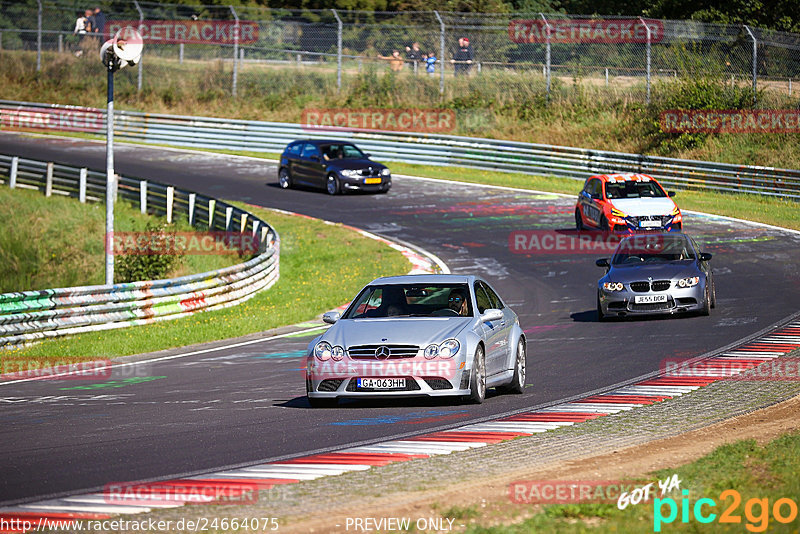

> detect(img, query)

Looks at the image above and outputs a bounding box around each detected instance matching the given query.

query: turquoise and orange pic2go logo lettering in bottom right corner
[653,490,797,532]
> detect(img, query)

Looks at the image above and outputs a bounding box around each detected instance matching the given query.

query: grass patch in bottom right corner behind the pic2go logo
[467,433,800,534]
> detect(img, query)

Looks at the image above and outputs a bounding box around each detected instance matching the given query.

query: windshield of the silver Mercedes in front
[343,284,472,319]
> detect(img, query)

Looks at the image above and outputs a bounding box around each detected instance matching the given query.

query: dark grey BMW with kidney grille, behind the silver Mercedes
[596,232,717,321]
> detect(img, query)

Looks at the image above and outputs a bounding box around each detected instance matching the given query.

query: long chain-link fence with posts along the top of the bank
[0,0,800,106]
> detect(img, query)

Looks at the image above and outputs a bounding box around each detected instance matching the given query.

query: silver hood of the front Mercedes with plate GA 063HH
[322,317,474,348]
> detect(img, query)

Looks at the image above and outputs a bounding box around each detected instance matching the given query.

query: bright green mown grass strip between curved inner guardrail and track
[0,203,410,365]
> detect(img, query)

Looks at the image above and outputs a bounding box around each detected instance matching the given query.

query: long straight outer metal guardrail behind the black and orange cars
[0,100,800,200]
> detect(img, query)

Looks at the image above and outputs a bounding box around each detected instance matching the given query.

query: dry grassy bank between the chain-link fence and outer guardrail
[6,51,800,168]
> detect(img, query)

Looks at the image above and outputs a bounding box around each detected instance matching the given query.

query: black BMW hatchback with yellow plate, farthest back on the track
[278,139,392,195]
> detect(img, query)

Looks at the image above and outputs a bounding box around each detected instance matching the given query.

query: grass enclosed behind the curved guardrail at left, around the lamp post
[0,187,240,293]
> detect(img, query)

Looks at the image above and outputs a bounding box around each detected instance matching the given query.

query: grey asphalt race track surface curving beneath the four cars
[0,134,800,503]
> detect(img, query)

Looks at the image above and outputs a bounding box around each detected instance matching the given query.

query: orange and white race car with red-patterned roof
[575,173,683,232]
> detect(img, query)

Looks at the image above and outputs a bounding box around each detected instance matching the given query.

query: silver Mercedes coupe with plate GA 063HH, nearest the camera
[306,274,525,407]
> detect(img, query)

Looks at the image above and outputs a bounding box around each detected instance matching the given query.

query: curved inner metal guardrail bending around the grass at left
[0,154,280,347]
